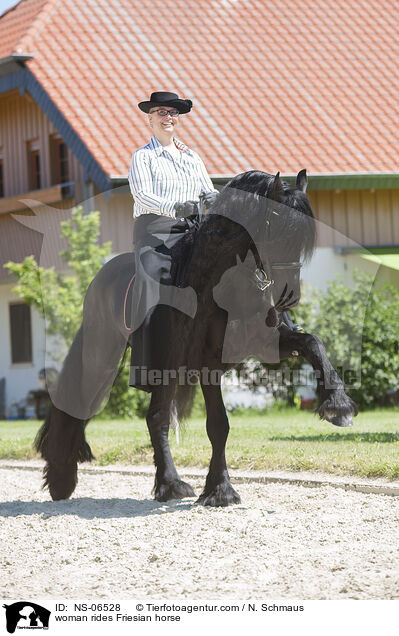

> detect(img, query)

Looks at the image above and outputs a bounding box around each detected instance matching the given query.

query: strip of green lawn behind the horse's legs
[0,408,399,479]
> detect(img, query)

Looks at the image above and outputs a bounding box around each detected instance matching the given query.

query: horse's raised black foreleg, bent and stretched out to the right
[280,325,358,426]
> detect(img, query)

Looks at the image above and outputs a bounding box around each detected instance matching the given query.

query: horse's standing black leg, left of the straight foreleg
[147,390,195,501]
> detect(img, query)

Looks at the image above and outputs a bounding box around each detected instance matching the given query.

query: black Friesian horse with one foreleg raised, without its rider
[35,170,357,506]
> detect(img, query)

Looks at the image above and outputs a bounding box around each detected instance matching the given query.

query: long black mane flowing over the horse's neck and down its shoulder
[171,170,316,413]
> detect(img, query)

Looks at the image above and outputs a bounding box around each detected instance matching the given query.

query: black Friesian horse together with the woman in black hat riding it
[35,93,357,506]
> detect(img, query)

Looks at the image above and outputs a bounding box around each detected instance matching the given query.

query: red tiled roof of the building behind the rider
[0,0,399,175]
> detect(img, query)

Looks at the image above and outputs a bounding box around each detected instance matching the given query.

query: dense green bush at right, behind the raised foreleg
[296,272,399,408]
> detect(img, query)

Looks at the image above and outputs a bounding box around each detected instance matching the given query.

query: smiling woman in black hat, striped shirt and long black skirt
[129,92,218,391]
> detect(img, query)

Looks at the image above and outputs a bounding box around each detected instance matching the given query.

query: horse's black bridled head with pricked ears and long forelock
[211,170,316,311]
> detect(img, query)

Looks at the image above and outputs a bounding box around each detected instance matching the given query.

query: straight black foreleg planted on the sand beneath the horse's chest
[197,384,240,506]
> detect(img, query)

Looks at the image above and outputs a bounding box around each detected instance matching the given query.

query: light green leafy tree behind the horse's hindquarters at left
[5,206,148,417]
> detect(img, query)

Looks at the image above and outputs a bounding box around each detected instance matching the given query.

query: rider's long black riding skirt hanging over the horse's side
[129,214,197,391]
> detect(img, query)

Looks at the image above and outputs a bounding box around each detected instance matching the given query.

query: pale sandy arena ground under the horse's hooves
[0,466,399,600]
